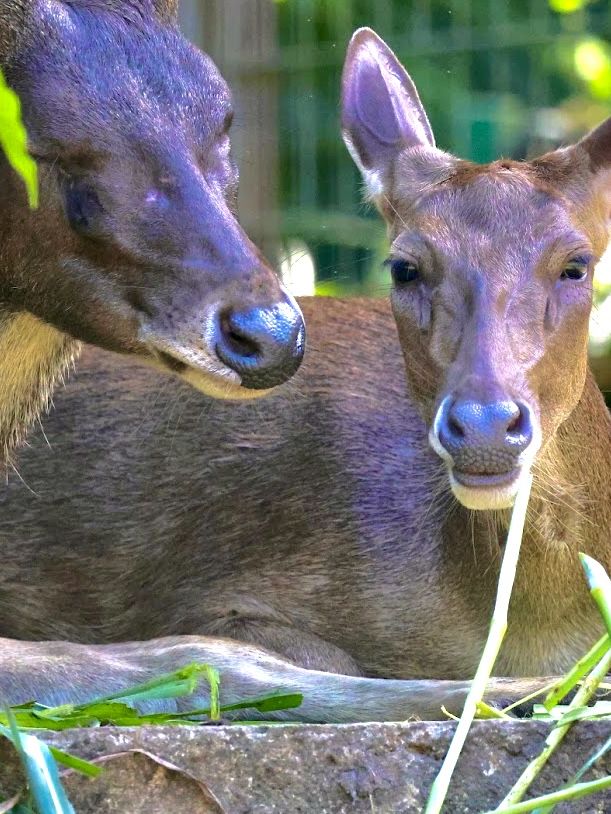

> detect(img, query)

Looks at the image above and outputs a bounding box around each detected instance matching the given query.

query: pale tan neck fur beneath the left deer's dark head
[0,310,79,466]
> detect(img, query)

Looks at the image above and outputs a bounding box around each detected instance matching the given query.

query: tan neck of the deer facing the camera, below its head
[444,375,611,675]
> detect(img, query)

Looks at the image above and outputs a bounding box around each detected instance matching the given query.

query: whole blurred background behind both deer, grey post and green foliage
[181,0,611,392]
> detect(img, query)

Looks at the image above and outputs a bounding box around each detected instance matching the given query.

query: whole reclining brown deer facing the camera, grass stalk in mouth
[0,30,611,721]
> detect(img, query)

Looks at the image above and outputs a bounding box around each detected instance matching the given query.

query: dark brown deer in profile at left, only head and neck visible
[0,0,304,466]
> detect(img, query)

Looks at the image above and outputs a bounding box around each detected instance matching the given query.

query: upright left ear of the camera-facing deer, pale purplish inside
[342,28,435,196]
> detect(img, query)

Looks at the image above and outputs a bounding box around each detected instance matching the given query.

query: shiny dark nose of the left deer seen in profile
[215,300,305,390]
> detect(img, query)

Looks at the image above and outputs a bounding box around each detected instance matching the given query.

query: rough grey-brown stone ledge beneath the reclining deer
[0,721,611,814]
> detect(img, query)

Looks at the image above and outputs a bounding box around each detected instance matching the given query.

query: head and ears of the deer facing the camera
[343,29,611,509]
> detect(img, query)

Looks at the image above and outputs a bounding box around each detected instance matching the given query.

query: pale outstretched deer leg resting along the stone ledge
[0,636,550,723]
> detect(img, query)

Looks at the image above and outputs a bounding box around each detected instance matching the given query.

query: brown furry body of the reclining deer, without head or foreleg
[0,300,611,696]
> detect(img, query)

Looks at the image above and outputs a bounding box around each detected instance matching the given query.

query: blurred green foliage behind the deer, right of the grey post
[278,0,611,296]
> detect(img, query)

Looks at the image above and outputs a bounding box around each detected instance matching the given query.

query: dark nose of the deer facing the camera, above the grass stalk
[437,399,533,475]
